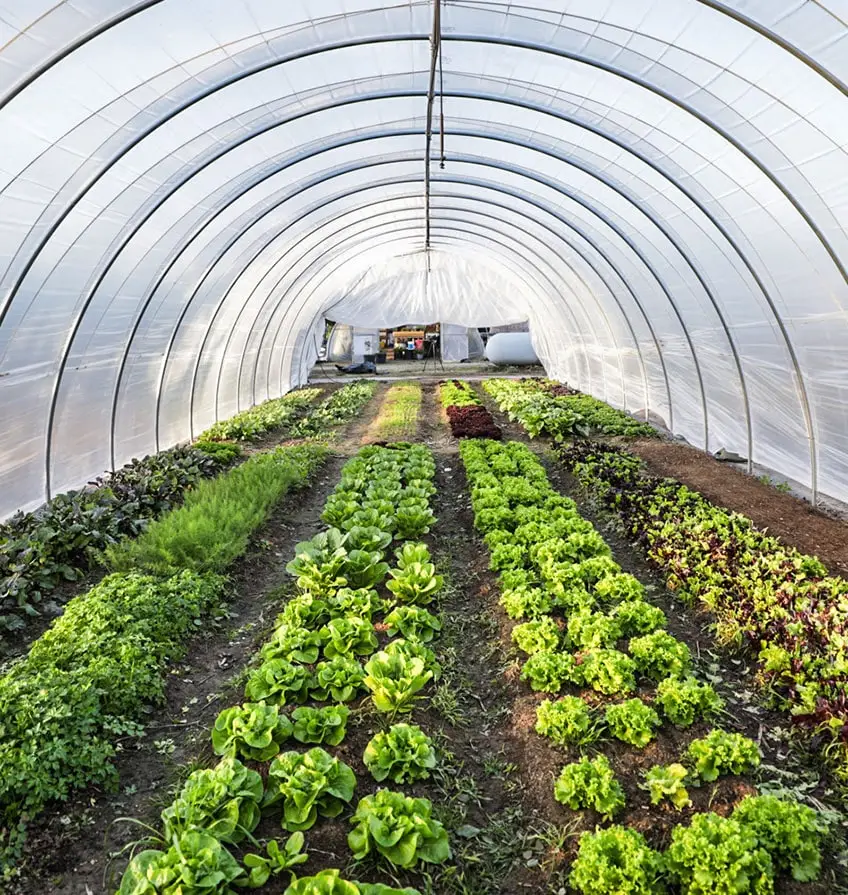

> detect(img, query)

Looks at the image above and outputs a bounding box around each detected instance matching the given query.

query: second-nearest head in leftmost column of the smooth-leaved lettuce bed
[162,758,263,843]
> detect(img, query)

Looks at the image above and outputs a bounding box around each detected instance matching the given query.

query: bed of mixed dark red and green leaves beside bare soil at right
[562,444,848,775]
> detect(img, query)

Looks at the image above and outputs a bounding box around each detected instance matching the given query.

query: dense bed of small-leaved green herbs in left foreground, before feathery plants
[0,572,224,874]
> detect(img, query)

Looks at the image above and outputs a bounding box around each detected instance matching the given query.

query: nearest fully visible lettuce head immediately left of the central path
[347,789,451,868]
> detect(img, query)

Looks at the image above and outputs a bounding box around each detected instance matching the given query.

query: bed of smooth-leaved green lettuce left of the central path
[111,443,451,895]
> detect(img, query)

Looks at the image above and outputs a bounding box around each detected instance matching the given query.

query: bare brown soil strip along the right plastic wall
[626,439,848,576]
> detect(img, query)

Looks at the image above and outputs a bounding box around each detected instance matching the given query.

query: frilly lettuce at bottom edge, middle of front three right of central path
[665,813,774,895]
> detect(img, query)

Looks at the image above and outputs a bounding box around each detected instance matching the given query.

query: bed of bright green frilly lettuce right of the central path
[460,441,824,895]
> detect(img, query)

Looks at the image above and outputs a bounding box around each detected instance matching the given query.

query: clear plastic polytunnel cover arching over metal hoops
[0,0,848,516]
